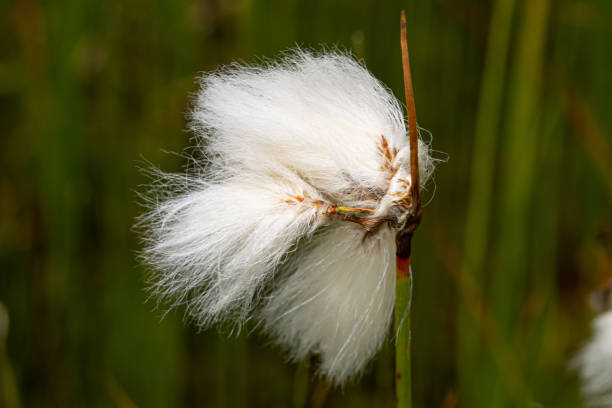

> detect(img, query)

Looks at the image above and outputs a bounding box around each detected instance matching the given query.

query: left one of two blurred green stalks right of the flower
[457,0,515,407]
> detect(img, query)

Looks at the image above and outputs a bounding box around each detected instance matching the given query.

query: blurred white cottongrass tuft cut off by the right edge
[572,310,612,408]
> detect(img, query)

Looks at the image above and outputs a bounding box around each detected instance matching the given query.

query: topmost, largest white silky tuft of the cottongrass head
[191,50,433,201]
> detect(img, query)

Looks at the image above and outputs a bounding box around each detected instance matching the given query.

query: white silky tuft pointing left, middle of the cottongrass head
[143,178,328,327]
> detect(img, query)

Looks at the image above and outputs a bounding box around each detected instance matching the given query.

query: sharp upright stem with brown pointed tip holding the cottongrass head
[395,10,421,408]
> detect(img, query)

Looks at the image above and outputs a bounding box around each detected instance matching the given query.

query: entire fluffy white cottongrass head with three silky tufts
[142,50,433,384]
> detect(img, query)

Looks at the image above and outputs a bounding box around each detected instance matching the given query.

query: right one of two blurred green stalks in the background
[488,0,549,407]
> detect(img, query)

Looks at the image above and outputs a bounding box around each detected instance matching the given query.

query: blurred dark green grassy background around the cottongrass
[0,0,612,408]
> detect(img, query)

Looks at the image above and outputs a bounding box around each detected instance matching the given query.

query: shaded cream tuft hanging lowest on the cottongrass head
[262,224,395,383]
